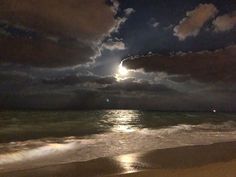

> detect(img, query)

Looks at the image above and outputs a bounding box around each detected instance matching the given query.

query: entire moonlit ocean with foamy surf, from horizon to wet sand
[0,110,236,171]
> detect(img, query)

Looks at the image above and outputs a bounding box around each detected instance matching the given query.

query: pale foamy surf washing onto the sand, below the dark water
[0,121,236,171]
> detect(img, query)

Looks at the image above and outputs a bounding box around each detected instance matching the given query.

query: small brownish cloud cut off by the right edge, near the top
[212,11,236,32]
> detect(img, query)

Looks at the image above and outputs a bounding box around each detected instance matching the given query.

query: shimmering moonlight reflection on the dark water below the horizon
[103,110,140,133]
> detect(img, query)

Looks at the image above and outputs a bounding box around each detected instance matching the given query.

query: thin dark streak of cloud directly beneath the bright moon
[42,75,177,94]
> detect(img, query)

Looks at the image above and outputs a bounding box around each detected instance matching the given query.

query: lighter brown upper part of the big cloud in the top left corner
[0,0,115,40]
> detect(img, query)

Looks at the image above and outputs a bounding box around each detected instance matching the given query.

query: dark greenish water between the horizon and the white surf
[0,110,236,143]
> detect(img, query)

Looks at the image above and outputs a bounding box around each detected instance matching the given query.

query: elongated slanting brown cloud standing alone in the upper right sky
[174,4,218,40]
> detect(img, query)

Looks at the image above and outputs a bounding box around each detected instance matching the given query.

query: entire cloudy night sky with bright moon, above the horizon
[0,0,236,111]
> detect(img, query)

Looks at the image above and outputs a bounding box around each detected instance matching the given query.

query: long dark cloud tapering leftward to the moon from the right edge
[123,45,236,82]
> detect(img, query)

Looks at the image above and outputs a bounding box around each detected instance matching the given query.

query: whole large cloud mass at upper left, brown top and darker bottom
[0,0,120,67]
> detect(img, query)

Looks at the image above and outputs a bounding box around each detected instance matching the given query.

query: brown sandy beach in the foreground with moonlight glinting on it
[0,142,236,177]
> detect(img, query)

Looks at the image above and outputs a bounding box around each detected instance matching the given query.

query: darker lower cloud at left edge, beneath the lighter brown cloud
[0,37,95,67]
